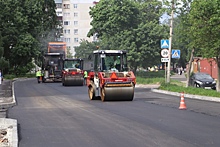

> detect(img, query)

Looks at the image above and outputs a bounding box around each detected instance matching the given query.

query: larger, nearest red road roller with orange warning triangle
[87,50,136,101]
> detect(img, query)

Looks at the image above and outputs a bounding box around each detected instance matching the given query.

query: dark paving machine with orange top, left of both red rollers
[42,42,66,82]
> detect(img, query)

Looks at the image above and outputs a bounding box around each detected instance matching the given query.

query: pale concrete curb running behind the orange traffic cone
[151,89,220,102]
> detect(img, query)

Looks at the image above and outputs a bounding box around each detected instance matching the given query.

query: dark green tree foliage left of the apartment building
[0,0,58,74]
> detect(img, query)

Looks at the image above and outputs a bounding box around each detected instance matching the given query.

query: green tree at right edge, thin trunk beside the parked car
[186,0,220,91]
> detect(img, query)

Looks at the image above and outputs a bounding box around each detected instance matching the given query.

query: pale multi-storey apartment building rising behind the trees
[55,0,98,56]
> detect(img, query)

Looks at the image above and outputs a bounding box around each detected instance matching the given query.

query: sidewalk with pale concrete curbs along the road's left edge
[0,80,18,147]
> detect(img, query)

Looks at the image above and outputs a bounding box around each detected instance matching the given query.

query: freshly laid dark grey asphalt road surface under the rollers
[8,79,220,147]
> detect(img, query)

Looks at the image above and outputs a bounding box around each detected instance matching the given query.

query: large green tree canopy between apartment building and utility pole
[88,0,168,71]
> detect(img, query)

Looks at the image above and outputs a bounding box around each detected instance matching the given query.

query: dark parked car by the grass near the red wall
[190,72,216,89]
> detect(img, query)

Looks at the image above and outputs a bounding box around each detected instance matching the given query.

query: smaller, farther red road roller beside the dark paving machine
[62,58,84,86]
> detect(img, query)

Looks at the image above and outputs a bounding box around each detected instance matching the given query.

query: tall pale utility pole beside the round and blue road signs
[167,0,174,83]
